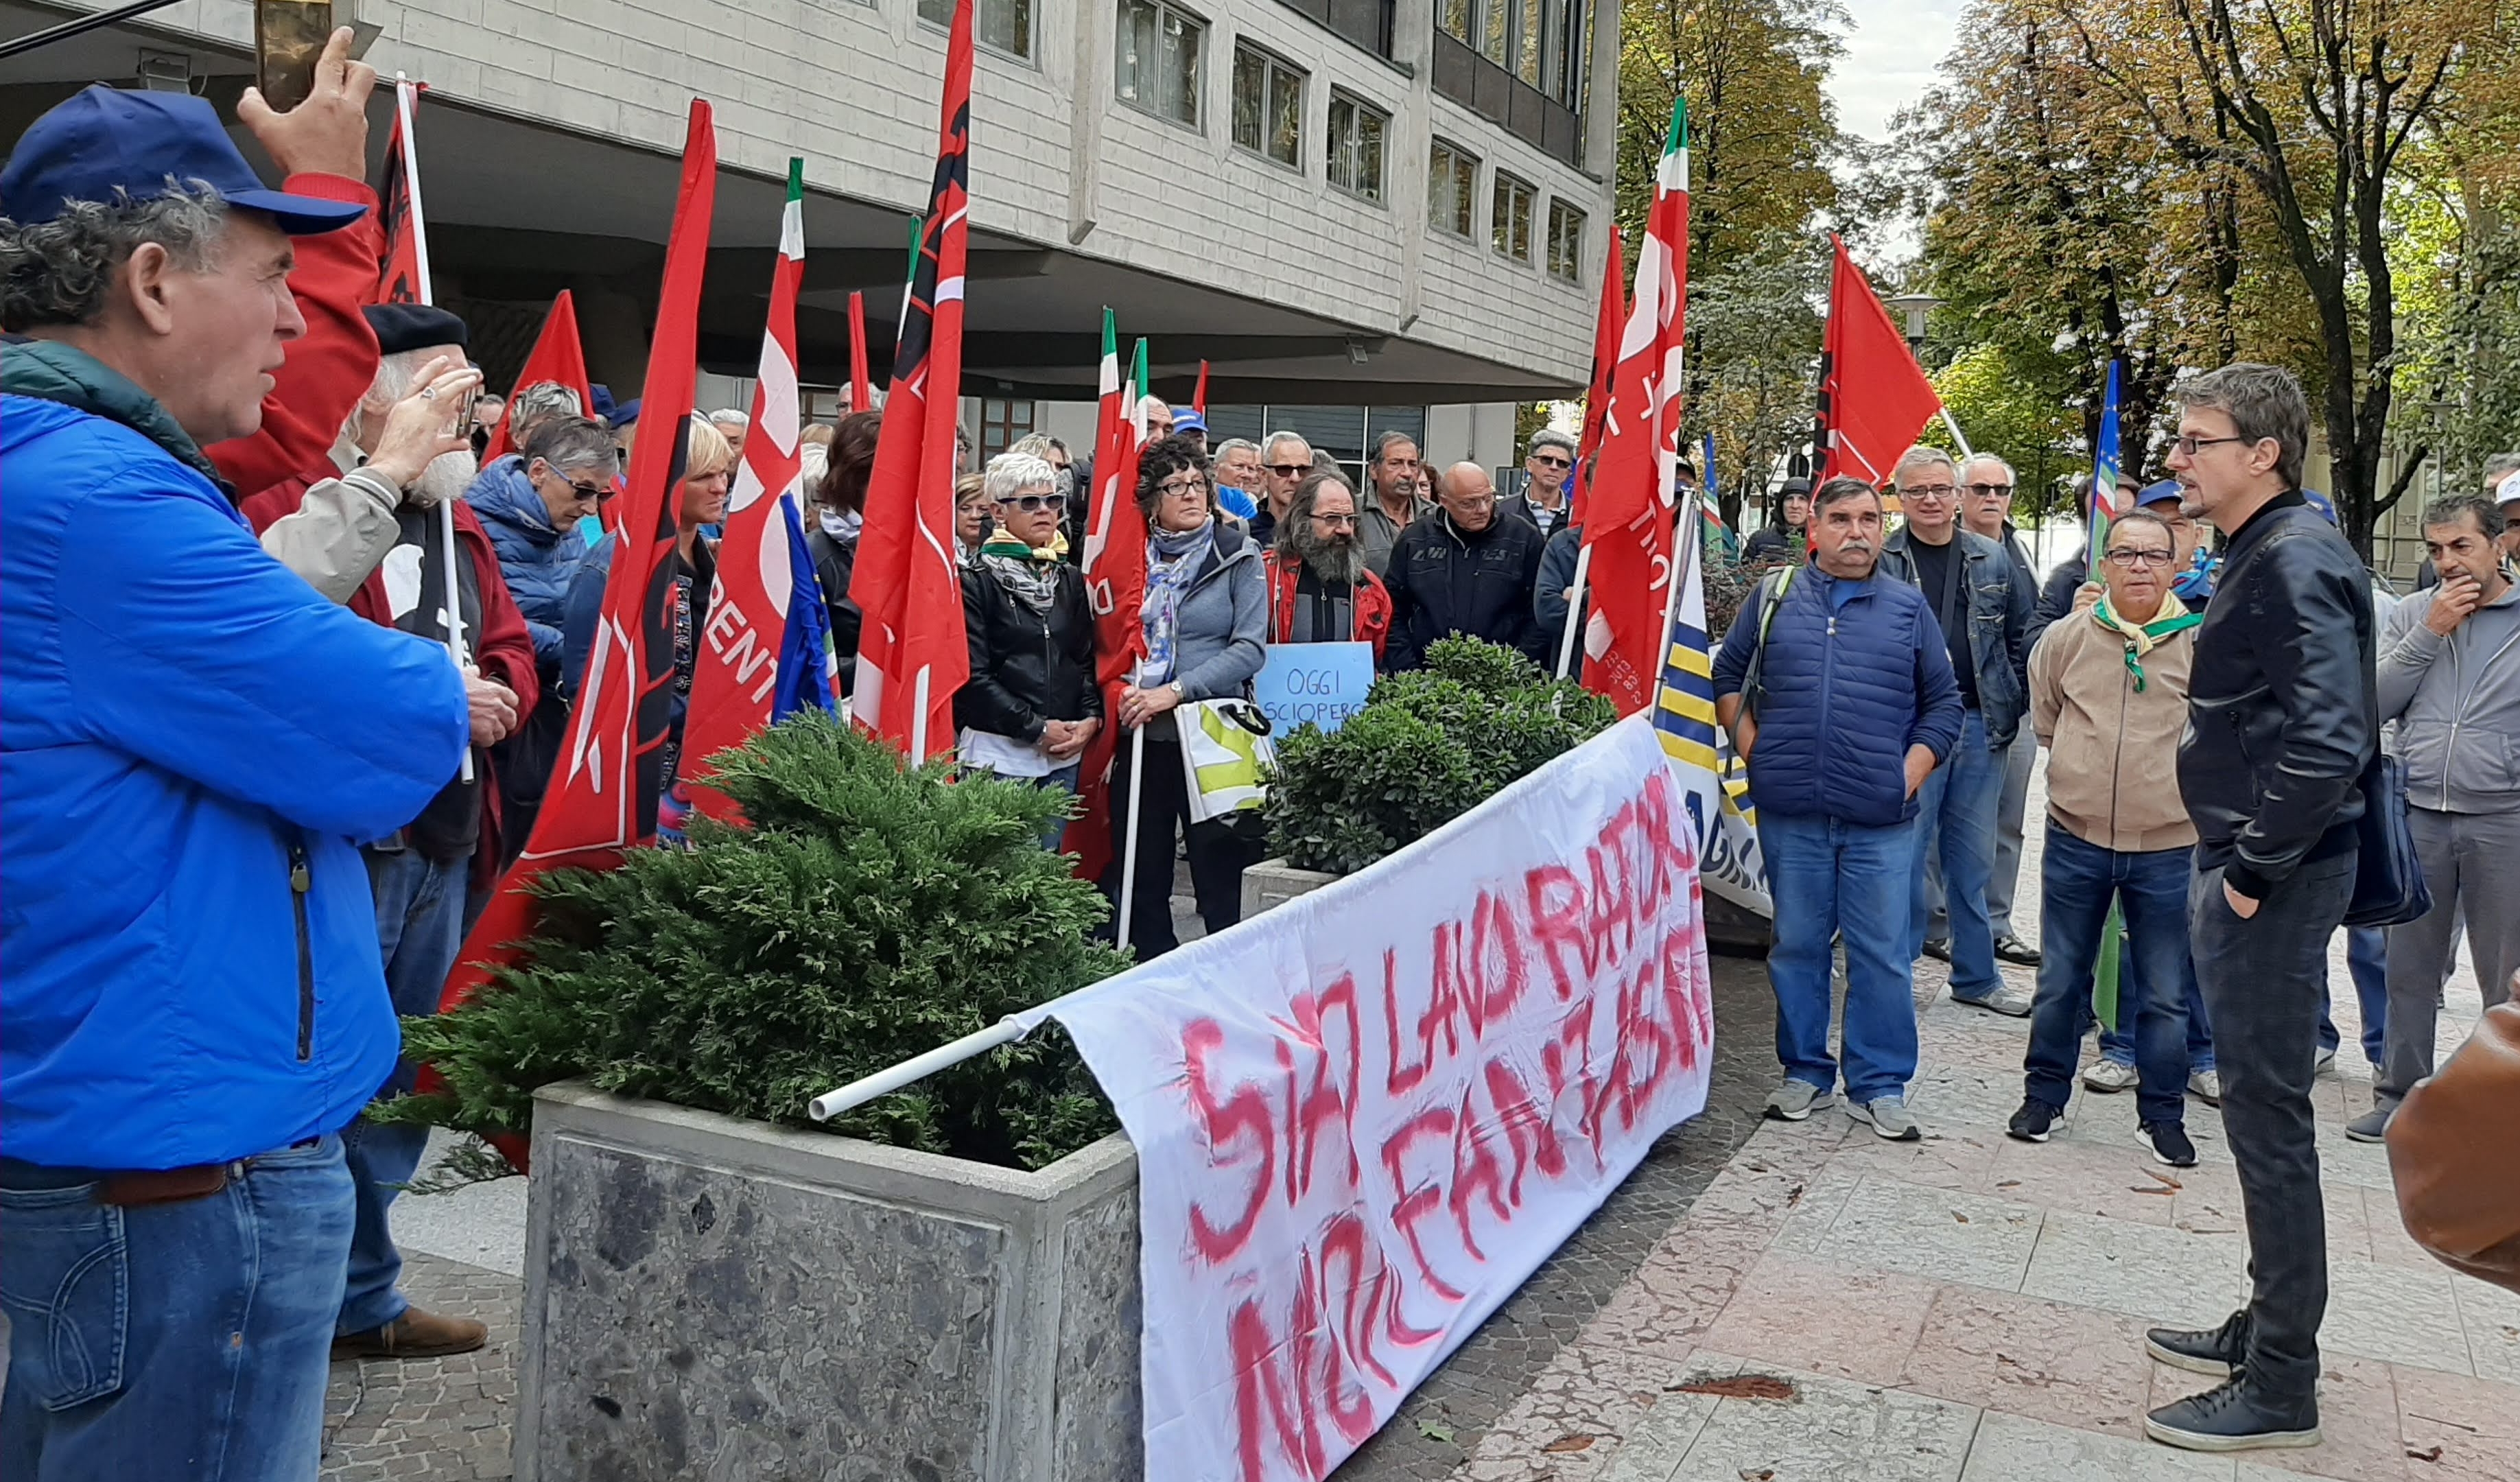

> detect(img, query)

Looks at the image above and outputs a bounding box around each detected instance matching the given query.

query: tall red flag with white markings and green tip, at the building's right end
[1583,101,1688,716]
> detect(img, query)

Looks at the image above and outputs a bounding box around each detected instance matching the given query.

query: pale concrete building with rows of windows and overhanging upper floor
[0,0,1618,464]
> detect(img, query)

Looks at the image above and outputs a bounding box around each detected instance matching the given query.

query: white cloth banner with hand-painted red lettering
[1056,716,1714,1482]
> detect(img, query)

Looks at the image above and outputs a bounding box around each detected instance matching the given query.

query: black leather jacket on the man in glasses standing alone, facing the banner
[2180,491,2379,899]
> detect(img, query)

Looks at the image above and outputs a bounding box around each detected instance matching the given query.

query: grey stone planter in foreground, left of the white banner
[514,1084,1144,1482]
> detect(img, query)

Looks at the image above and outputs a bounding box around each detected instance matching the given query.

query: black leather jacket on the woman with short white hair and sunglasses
[952,560,1101,741]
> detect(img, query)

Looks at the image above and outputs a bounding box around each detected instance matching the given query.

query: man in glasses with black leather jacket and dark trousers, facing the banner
[2145,363,2379,1452]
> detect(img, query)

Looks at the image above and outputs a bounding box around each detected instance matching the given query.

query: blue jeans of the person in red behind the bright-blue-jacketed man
[335,849,471,1333]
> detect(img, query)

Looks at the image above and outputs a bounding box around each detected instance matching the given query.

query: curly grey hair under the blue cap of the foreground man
[0,176,227,333]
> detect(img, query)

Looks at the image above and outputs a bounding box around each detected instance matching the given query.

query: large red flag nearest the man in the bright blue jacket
[441,98,718,1018]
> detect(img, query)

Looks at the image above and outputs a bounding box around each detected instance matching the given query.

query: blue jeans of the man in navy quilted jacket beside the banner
[1759,809,1915,1101]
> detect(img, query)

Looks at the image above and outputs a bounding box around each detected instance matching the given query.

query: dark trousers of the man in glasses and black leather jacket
[2187,854,2354,1401]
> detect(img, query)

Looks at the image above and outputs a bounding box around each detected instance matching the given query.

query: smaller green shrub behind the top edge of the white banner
[1268,637,1618,875]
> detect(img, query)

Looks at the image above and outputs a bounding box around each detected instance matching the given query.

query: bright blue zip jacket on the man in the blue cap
[0,343,469,1169]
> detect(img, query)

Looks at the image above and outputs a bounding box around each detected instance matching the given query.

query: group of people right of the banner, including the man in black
[1714,363,2520,1452]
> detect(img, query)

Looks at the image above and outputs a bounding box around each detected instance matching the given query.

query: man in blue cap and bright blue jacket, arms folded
[0,43,486,1479]
